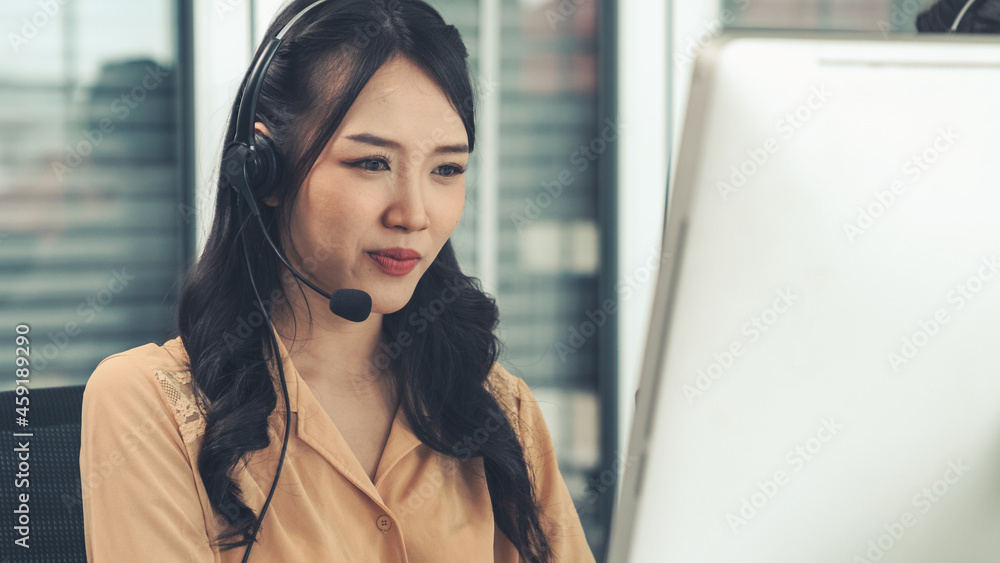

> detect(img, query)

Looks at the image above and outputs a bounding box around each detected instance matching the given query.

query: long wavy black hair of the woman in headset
[178,0,551,562]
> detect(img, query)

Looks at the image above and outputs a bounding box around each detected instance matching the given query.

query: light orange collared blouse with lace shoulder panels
[80,328,594,563]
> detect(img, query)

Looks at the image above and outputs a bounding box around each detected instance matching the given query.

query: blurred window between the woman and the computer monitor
[433,0,618,555]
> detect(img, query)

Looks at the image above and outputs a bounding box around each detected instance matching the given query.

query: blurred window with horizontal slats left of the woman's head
[0,0,187,389]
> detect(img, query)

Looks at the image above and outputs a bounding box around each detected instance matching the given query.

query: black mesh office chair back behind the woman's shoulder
[0,385,87,563]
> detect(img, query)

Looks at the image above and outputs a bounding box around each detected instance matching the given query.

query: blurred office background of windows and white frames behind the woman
[0,0,944,560]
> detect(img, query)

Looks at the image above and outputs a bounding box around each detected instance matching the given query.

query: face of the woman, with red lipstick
[271,57,469,315]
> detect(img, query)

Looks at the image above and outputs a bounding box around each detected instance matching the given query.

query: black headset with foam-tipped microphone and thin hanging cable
[222,0,372,563]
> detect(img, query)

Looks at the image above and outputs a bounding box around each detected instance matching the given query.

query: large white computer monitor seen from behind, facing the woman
[609,34,1000,563]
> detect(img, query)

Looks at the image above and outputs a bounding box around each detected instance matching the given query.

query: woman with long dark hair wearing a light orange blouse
[80,0,594,563]
